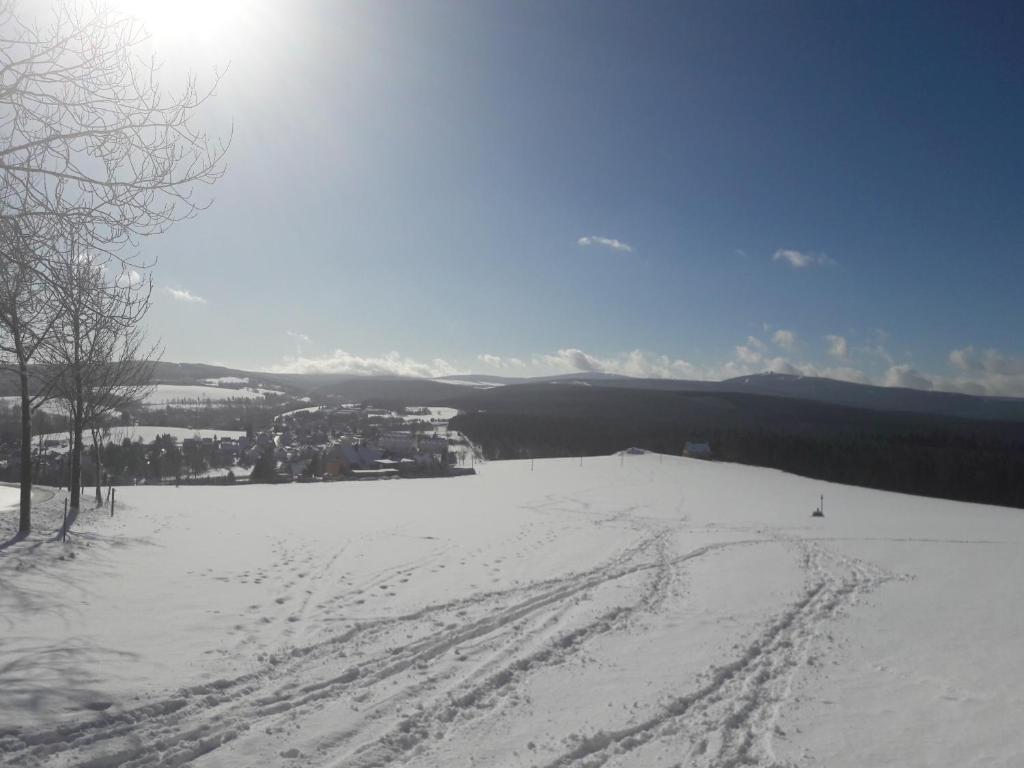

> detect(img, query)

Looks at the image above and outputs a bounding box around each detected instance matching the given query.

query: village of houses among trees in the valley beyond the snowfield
[0,403,476,487]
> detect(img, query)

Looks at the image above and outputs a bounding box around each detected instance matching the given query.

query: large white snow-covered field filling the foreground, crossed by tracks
[0,455,1024,768]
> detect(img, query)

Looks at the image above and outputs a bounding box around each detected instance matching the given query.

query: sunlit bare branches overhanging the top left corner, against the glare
[0,0,228,260]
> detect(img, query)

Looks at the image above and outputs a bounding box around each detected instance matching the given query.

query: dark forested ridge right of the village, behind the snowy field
[451,390,1024,508]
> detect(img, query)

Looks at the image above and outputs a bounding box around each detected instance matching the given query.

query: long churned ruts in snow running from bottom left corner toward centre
[0,530,714,767]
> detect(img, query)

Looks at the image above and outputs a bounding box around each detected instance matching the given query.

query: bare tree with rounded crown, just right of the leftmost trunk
[45,243,159,512]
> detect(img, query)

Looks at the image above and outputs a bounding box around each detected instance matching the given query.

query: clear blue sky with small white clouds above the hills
[125,0,1024,395]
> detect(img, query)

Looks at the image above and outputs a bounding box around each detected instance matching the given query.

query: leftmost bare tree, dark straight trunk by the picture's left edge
[0,220,56,534]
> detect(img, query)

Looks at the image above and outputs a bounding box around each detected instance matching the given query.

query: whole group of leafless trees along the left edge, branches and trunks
[0,0,227,534]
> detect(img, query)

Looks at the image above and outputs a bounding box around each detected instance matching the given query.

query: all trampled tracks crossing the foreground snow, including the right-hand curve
[0,475,894,768]
